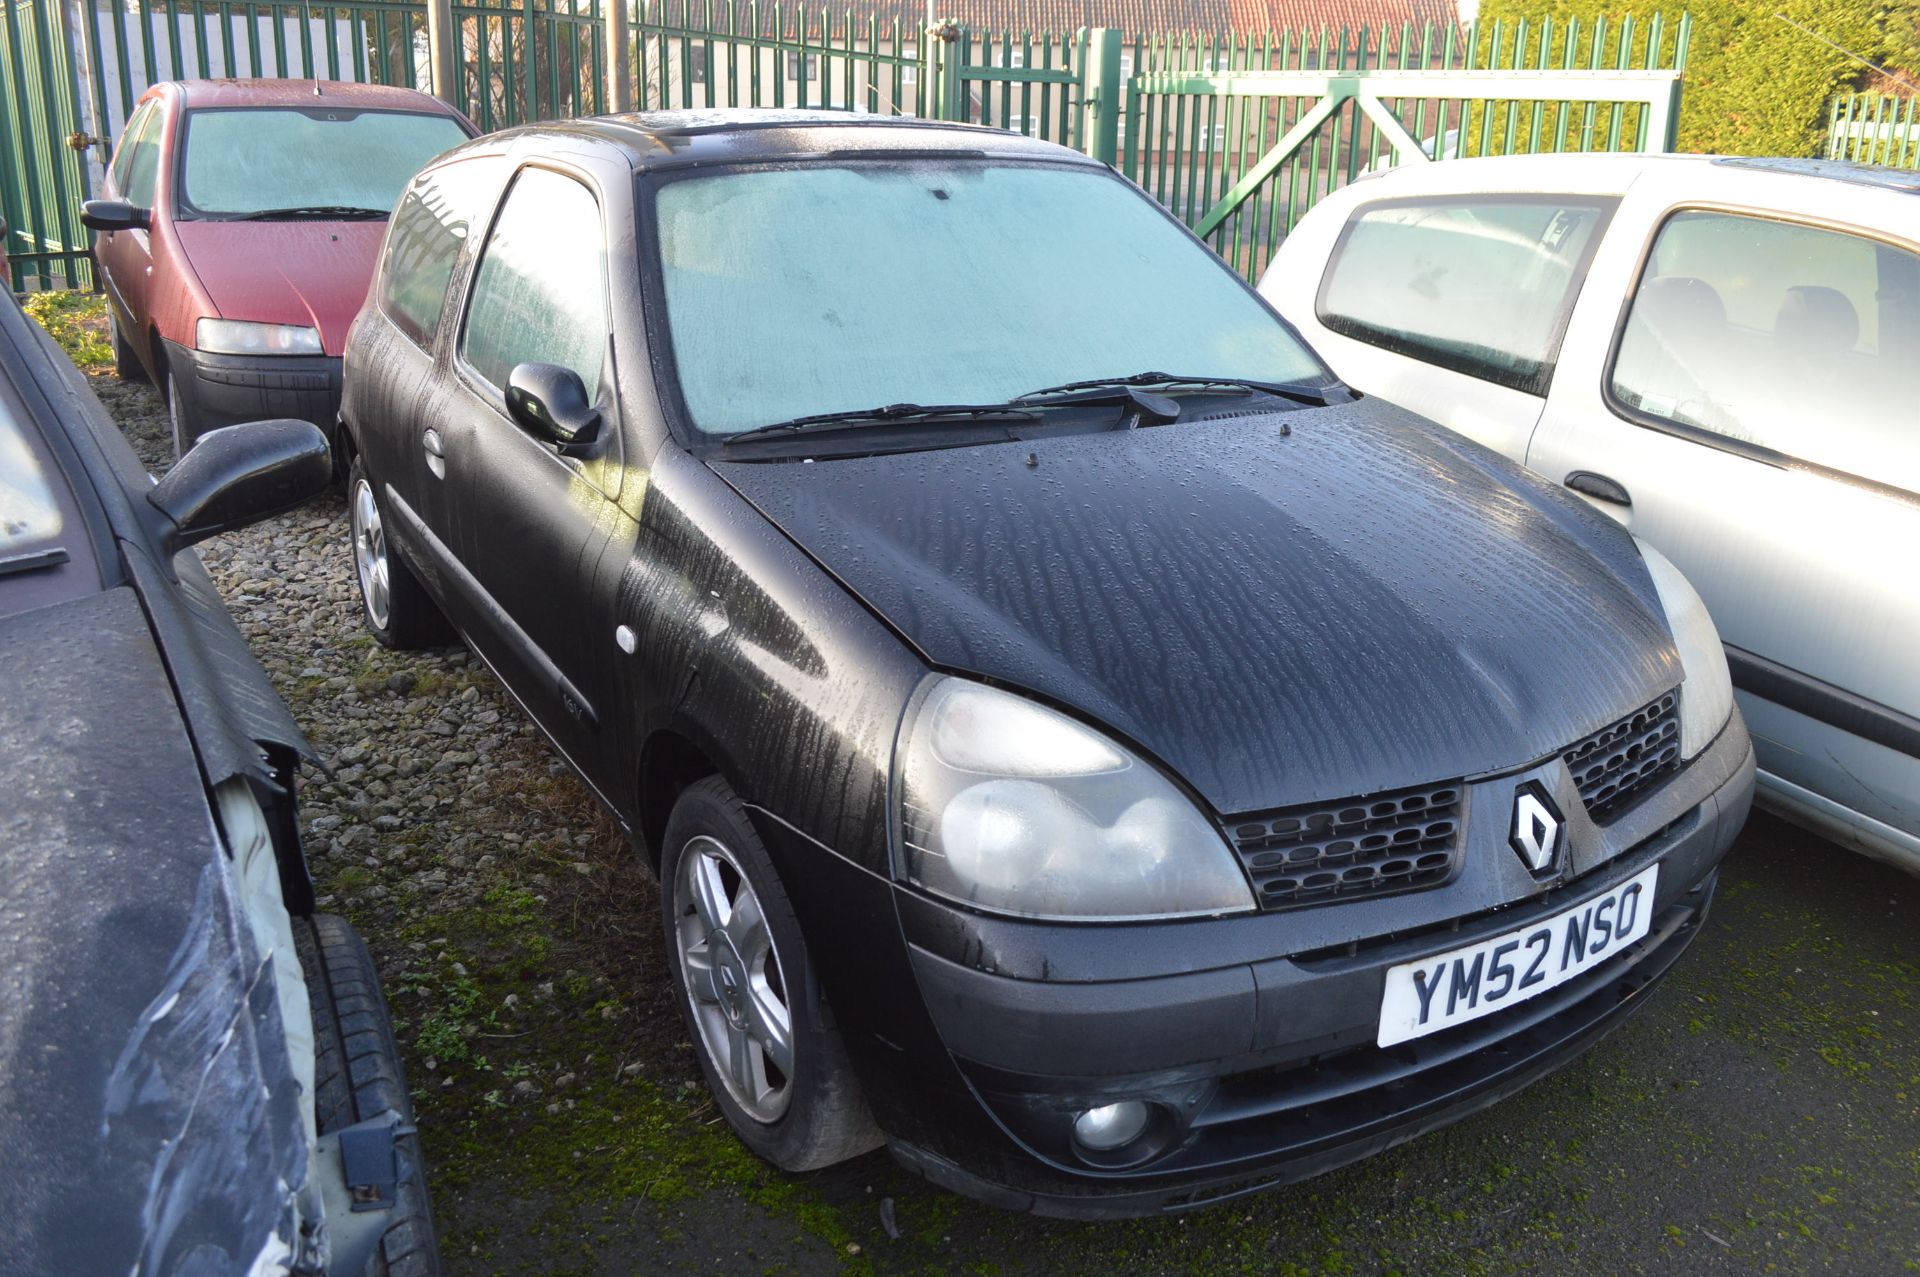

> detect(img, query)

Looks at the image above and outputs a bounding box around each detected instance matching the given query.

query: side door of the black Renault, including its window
[444,163,622,778]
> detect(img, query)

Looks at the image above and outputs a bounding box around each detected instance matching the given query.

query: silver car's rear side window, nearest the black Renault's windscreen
[1317,196,1615,396]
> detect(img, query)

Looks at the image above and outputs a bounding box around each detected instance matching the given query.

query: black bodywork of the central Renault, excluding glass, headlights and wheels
[344,113,1751,1210]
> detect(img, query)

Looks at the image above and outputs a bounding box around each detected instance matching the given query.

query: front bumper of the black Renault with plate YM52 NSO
[893,714,1753,1217]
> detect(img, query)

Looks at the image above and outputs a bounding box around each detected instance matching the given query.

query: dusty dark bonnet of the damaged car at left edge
[0,586,307,1273]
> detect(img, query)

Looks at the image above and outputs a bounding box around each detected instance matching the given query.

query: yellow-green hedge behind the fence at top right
[1480,0,1920,156]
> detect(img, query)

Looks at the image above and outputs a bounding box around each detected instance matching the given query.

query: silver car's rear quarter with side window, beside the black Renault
[1261,181,1617,461]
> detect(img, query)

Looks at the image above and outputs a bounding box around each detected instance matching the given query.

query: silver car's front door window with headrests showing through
[1613,211,1920,492]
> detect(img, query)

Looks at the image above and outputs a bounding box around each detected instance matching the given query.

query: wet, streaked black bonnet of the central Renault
[716,401,1680,812]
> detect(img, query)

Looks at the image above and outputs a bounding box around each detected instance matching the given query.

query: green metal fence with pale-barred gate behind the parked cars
[11,0,1697,291]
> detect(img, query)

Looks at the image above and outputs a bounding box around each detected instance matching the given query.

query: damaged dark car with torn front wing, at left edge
[0,300,440,1277]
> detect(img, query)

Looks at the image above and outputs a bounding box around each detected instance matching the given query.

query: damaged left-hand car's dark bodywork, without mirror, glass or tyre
[0,300,332,1273]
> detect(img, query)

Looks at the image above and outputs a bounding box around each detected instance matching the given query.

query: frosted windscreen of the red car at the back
[180,108,467,217]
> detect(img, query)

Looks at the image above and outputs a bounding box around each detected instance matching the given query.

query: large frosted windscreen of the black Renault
[655,161,1325,434]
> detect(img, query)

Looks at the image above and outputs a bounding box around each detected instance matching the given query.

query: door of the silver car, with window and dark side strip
[1528,165,1920,855]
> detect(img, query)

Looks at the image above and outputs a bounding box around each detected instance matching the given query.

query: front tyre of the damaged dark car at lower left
[294,914,440,1277]
